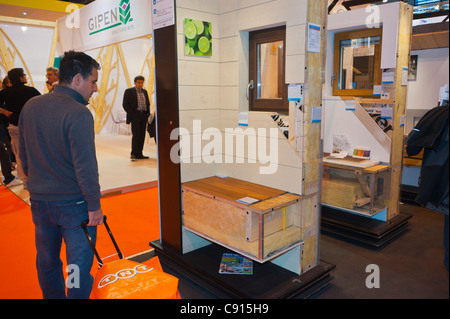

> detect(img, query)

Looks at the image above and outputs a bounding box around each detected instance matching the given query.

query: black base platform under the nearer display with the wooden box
[150,240,336,299]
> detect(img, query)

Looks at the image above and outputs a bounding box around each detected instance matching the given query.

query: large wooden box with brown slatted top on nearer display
[182,176,301,262]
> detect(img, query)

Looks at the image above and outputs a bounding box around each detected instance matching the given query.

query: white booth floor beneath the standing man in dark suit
[7,134,158,204]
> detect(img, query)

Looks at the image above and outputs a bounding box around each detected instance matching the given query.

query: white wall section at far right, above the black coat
[406,48,449,110]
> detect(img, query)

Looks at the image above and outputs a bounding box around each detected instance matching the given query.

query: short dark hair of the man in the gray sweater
[59,50,100,84]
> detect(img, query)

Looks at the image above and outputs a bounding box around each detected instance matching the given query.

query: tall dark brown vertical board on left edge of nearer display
[153,18,183,253]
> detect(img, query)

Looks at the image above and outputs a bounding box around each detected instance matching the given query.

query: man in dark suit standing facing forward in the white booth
[122,75,150,161]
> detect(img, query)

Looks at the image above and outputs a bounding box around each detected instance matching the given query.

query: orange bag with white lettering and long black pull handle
[82,216,181,299]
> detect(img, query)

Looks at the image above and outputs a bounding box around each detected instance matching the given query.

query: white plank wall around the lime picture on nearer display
[177,0,307,193]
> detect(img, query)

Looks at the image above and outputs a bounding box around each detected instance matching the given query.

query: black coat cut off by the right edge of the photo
[406,103,449,271]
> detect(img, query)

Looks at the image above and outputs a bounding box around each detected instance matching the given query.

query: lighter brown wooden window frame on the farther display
[333,28,383,97]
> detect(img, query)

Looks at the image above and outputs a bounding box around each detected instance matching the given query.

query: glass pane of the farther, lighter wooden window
[338,36,380,90]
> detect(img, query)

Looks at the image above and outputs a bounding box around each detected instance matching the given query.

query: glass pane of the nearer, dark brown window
[256,41,284,99]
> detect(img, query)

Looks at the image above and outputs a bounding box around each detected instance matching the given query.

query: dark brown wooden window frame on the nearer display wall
[249,26,289,113]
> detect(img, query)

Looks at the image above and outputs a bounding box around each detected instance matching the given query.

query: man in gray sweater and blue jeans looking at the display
[19,51,103,299]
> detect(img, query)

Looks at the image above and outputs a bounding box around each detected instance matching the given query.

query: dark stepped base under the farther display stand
[321,206,411,247]
